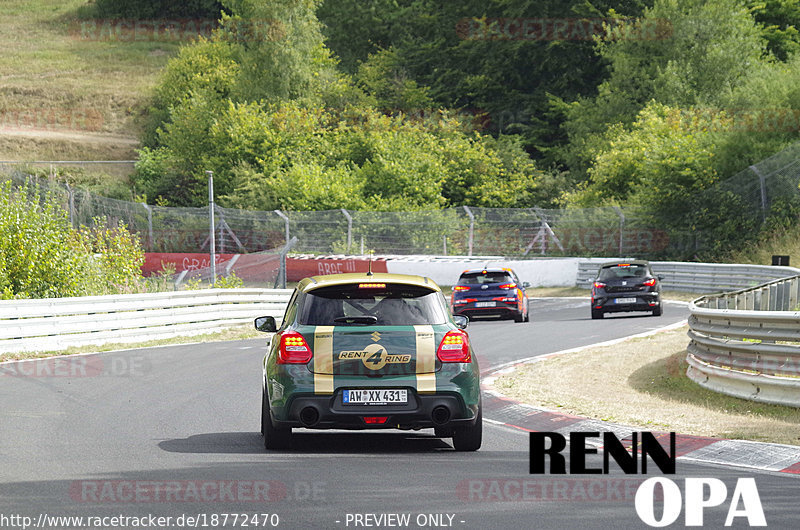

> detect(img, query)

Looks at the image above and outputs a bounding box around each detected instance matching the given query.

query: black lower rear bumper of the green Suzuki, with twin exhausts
[272,389,478,430]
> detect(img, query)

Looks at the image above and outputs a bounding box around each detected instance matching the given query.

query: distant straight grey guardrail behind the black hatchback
[576,260,800,293]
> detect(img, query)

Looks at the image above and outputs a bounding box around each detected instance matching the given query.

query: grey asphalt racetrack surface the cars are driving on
[0,299,800,529]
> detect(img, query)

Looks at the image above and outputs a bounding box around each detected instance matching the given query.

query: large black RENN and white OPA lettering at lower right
[528,431,767,528]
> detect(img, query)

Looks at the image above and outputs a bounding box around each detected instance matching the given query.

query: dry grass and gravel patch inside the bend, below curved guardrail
[495,328,800,445]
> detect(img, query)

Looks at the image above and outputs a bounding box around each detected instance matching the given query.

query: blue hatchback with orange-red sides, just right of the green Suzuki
[450,268,530,322]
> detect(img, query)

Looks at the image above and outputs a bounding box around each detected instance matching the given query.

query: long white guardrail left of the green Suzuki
[0,289,292,355]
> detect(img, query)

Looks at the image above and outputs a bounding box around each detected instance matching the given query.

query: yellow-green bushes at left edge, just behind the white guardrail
[0,181,144,298]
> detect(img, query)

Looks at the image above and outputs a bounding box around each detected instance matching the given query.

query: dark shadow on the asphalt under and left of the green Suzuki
[158,430,453,454]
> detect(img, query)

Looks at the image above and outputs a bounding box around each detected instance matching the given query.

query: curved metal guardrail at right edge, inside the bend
[686,276,800,407]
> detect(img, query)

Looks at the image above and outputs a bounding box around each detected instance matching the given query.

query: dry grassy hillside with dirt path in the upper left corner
[0,0,186,165]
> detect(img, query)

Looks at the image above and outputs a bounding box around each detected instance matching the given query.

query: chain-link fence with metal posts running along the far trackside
[0,139,800,259]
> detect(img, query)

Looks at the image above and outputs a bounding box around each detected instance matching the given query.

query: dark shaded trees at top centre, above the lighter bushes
[319,0,651,165]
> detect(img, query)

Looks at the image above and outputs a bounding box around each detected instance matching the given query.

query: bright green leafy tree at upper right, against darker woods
[561,0,767,179]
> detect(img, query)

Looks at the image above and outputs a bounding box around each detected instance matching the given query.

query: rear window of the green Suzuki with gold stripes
[298,283,448,326]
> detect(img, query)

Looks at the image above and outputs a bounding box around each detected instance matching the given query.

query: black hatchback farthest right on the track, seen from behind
[592,261,661,318]
